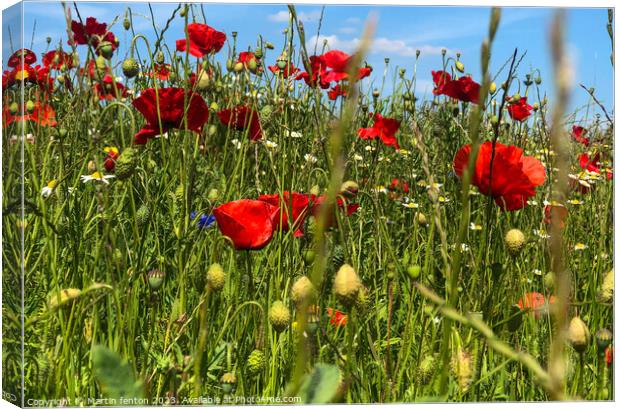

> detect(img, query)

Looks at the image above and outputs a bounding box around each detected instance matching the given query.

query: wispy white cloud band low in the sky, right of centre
[308,34,450,57]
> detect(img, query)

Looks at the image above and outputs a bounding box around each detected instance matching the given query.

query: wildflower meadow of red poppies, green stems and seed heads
[2,3,614,406]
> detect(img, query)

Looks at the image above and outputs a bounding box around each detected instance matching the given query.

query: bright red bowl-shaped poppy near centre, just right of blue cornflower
[213,199,280,250]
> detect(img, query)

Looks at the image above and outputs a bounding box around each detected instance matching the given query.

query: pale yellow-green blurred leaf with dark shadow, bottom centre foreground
[299,364,340,403]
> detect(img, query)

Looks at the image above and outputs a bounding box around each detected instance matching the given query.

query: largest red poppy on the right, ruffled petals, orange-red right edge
[454,142,545,211]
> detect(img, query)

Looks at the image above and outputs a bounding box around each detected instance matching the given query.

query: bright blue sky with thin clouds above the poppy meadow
[3,1,614,120]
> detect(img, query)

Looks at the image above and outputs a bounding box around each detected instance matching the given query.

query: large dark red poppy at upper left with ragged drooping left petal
[133,88,209,145]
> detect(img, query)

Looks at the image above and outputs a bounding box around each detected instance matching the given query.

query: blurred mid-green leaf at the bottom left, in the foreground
[91,345,144,400]
